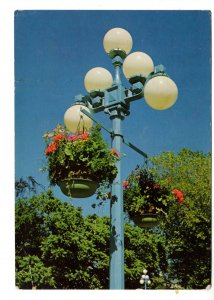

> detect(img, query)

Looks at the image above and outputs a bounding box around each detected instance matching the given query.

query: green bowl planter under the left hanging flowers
[58,178,99,198]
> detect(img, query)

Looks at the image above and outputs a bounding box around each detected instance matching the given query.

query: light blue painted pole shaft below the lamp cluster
[110,116,124,289]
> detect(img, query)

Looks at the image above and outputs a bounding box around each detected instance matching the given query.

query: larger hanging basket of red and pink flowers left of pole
[43,125,120,198]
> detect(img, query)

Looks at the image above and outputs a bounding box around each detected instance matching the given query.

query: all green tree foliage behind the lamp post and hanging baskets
[16,149,211,289]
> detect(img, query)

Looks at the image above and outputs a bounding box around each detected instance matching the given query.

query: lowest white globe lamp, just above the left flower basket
[64,104,93,132]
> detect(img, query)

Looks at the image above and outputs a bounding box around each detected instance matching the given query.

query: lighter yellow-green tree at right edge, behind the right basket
[152,149,211,289]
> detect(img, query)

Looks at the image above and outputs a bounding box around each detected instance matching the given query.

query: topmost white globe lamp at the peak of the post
[103,28,132,54]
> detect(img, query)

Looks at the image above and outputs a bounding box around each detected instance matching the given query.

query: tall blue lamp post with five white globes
[64,28,178,289]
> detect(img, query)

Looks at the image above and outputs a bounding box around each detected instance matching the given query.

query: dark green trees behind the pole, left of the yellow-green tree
[16,191,167,289]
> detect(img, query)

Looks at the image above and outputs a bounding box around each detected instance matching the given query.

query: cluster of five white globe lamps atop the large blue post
[64,28,178,132]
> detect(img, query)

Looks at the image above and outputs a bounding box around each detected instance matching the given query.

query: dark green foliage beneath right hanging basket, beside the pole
[125,224,167,289]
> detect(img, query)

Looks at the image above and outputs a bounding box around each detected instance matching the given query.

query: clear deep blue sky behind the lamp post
[15,10,211,215]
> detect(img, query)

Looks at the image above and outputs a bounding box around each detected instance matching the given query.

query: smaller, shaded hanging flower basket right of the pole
[123,166,169,228]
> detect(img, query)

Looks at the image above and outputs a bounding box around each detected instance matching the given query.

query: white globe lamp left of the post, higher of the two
[84,67,113,93]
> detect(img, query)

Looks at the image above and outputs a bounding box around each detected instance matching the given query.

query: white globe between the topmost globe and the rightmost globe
[123,52,154,79]
